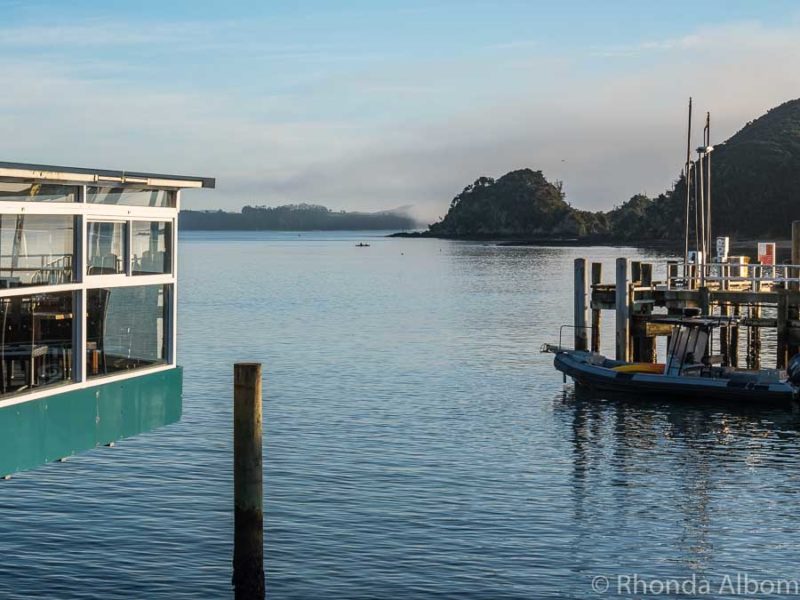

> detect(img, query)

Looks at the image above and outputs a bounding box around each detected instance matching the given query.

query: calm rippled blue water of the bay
[0,233,800,599]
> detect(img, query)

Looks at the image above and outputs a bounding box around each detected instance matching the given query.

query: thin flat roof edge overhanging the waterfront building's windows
[0,161,216,189]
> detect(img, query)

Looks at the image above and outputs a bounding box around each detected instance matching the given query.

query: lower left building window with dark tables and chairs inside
[0,292,73,395]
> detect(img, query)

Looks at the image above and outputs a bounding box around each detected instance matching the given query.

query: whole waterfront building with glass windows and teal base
[0,162,214,475]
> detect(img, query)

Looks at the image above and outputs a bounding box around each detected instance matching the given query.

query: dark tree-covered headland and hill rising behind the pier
[397,99,800,244]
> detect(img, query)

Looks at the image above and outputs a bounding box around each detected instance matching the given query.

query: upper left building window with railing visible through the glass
[0,215,75,288]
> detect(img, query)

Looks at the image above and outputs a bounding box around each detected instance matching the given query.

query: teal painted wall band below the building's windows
[0,367,183,476]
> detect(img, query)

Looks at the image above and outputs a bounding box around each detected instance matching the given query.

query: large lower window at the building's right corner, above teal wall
[86,285,169,378]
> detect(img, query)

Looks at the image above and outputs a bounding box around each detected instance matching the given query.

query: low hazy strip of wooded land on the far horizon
[179,204,419,231]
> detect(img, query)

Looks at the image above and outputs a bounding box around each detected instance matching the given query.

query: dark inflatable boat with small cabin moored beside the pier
[542,317,800,403]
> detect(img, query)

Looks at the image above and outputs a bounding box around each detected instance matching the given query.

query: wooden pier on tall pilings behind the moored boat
[573,221,800,369]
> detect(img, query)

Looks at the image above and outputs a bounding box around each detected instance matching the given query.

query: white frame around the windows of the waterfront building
[0,185,180,408]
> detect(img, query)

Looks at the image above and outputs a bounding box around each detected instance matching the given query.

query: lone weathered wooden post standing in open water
[233,363,265,600]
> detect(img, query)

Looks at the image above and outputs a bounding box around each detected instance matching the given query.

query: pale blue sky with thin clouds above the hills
[0,0,800,222]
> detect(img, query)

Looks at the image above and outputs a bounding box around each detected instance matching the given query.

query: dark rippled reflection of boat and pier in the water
[553,386,800,574]
